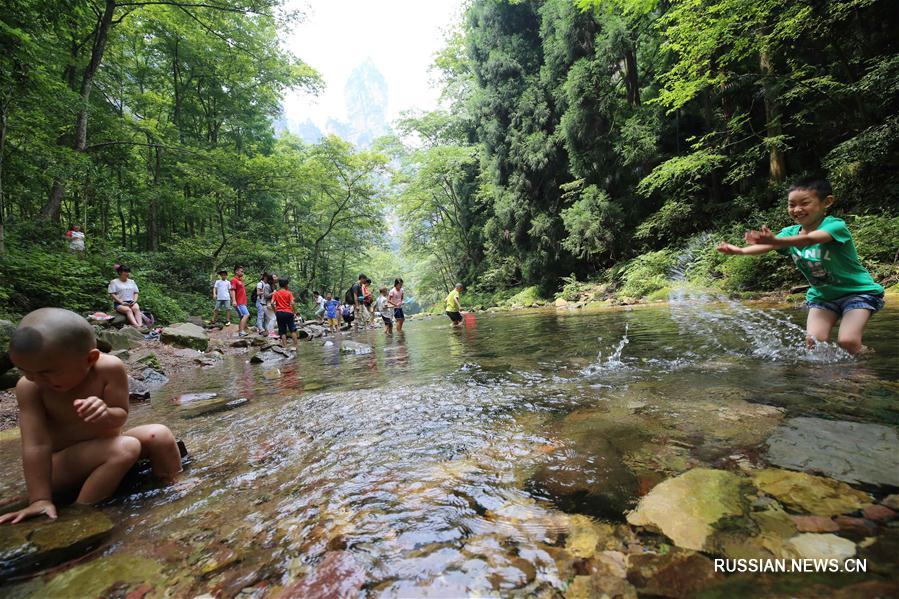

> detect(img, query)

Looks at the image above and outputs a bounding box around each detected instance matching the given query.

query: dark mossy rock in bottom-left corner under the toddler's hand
[0,505,113,577]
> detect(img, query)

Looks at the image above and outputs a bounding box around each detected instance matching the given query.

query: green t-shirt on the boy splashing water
[777,216,883,302]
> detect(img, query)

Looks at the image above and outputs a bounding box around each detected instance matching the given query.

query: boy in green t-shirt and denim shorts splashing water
[718,179,883,354]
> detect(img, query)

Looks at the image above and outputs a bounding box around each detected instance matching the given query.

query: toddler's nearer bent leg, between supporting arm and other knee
[52,435,140,504]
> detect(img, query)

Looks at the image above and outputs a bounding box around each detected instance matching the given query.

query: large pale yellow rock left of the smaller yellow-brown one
[627,468,748,550]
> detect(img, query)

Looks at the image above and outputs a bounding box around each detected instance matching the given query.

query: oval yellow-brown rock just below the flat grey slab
[752,468,871,516]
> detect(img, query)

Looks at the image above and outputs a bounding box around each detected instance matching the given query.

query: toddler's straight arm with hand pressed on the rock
[0,378,56,524]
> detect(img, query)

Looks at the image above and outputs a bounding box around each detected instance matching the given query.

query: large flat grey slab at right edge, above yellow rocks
[766,417,899,488]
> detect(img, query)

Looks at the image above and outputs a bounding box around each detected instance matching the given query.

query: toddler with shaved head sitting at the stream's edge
[0,308,181,523]
